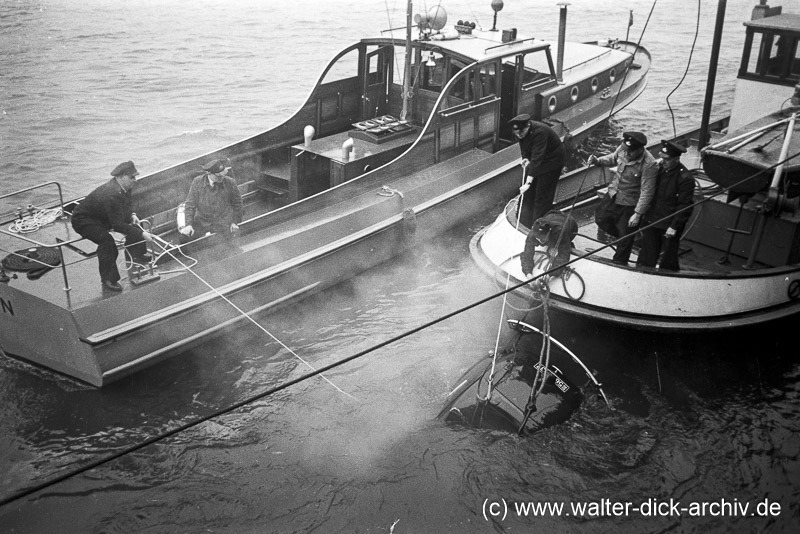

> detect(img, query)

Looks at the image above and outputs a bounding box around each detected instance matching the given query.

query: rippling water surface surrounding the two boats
[0,0,800,533]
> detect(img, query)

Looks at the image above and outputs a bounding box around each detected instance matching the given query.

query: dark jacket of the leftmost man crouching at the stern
[72,178,142,241]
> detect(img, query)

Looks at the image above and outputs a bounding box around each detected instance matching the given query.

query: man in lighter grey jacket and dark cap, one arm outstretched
[589,132,658,265]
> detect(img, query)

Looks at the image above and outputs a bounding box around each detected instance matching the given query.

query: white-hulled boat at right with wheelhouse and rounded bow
[471,2,800,332]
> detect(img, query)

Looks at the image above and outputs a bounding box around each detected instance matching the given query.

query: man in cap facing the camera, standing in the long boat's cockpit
[178,159,243,243]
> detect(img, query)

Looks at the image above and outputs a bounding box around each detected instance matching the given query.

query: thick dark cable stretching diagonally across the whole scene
[0,152,800,506]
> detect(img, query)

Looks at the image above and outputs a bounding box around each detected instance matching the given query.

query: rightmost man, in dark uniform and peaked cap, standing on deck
[636,141,694,271]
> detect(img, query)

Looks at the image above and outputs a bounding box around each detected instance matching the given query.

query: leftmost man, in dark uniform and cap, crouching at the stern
[72,161,153,291]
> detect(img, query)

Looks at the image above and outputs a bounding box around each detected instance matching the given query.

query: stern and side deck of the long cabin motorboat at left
[0,149,500,309]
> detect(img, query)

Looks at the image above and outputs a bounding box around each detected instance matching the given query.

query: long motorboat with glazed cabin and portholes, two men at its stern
[0,3,650,386]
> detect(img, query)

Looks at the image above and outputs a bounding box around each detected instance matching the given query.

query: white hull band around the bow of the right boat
[471,207,800,331]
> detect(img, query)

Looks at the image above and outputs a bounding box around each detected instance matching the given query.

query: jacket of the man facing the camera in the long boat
[185,174,244,229]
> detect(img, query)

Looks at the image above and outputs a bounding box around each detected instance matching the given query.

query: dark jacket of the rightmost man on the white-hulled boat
[643,163,694,232]
